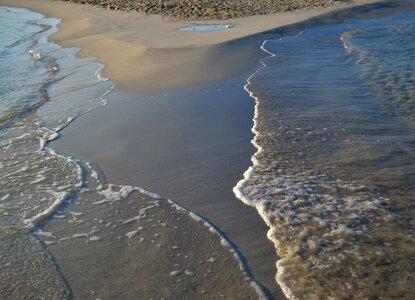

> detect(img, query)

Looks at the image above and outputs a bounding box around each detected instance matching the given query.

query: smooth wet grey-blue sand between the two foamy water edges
[50,72,288,297]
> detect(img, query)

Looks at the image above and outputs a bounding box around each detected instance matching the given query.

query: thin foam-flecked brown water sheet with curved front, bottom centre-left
[39,186,258,299]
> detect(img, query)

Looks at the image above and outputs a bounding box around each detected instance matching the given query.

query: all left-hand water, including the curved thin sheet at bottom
[0,7,263,299]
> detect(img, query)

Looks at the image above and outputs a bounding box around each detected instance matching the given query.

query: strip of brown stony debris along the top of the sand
[57,0,353,19]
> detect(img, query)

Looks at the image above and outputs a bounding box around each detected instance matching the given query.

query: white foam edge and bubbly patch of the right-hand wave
[233,29,402,299]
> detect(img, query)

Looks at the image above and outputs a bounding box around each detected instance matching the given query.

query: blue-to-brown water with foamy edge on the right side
[234,11,415,299]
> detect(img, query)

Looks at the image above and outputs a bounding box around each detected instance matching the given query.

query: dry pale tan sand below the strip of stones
[0,0,386,91]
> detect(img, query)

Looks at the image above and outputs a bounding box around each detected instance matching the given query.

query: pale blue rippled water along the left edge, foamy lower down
[0,7,114,299]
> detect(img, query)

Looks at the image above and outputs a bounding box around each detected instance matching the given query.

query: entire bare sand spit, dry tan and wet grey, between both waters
[0,0,411,298]
